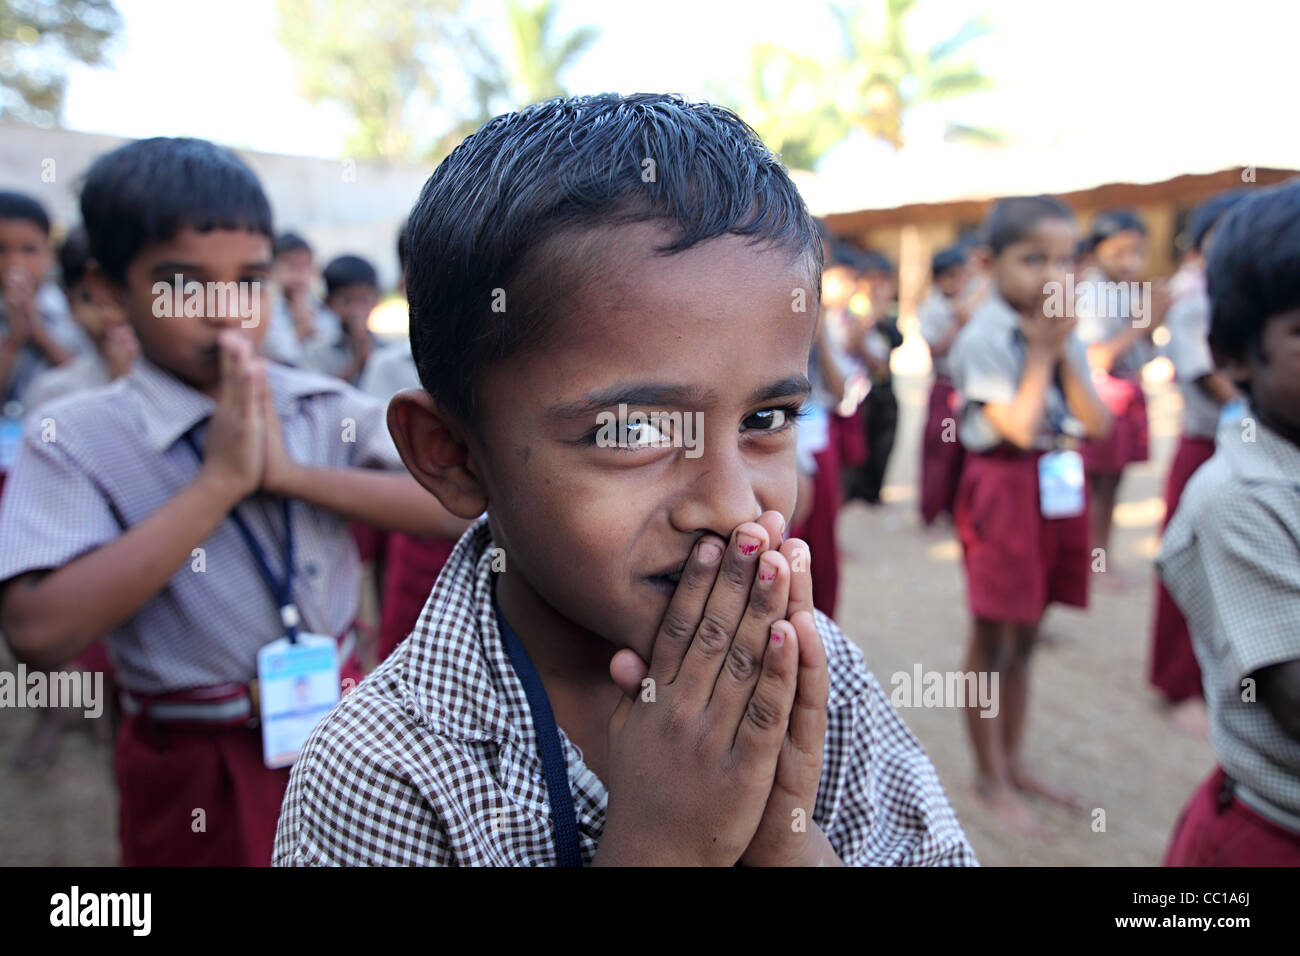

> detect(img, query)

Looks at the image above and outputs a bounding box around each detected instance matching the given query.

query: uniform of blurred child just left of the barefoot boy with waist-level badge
[920,289,966,524]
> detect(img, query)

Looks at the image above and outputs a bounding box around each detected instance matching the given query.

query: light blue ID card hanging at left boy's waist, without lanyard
[257,632,339,770]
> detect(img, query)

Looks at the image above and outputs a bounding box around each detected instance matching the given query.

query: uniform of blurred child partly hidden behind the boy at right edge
[1148,286,1219,702]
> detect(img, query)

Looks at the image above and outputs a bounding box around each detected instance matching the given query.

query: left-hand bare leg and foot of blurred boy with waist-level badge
[963,618,1053,838]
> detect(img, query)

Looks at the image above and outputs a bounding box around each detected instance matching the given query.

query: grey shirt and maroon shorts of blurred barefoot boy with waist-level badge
[950,294,1091,624]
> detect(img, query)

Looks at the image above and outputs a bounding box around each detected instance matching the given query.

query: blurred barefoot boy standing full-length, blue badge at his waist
[950,196,1109,836]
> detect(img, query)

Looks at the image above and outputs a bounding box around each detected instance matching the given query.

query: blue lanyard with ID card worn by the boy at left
[183,432,341,770]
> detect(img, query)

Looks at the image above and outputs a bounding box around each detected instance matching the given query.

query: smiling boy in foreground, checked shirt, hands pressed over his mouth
[276,95,974,865]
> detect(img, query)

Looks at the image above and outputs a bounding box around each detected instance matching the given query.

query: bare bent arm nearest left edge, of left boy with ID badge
[0,475,245,670]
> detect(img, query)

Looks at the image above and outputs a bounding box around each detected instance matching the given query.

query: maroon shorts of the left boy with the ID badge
[116,654,364,866]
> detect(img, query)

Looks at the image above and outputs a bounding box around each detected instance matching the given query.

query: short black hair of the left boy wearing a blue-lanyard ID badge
[81,137,276,284]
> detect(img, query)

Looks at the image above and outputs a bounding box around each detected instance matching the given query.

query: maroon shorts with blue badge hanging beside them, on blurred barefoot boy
[953,451,1091,624]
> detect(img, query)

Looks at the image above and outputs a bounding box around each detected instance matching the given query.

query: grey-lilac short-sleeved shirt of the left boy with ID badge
[0,358,402,693]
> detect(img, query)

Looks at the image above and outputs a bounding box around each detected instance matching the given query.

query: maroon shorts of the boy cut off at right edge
[1164,767,1300,866]
